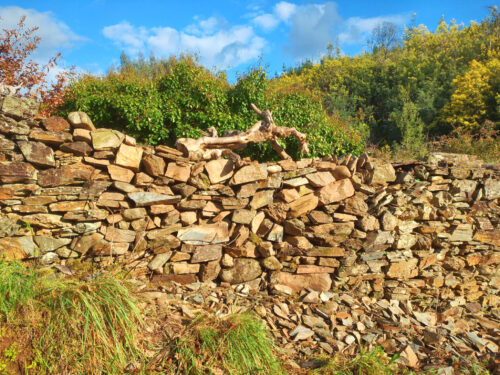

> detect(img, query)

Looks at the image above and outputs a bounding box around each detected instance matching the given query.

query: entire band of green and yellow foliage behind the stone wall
[60,8,500,160]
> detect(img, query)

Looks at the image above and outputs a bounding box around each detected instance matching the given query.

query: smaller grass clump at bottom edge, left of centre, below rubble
[161,313,285,375]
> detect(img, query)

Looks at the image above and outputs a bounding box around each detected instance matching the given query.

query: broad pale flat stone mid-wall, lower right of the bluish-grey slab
[177,222,229,245]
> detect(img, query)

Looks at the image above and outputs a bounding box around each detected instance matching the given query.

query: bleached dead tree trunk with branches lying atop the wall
[175,103,309,160]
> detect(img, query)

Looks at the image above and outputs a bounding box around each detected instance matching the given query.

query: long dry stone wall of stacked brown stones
[0,96,500,304]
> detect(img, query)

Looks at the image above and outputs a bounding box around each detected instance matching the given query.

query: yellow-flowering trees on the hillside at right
[274,8,500,148]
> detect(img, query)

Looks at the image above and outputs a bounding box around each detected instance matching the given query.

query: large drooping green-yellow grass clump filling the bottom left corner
[0,261,142,374]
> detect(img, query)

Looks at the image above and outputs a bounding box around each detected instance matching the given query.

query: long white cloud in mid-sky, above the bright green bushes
[103,17,266,69]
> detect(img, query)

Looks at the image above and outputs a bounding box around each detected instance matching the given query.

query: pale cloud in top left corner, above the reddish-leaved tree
[0,6,85,63]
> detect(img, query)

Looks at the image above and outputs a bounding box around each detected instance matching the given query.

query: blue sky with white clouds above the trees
[0,0,496,79]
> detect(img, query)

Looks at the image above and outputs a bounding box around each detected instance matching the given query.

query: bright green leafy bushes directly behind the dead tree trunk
[61,56,364,159]
